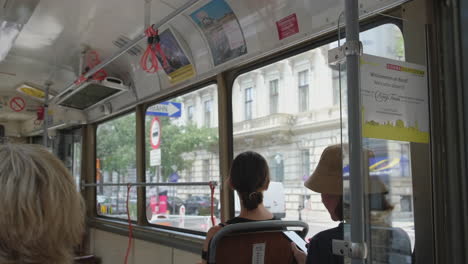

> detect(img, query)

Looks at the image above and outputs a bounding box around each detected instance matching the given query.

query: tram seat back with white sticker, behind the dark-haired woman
[208,220,309,264]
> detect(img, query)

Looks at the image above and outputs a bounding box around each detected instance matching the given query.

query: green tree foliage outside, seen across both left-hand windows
[96,113,218,181]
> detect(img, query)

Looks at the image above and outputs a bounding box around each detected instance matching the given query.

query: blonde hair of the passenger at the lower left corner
[0,144,84,264]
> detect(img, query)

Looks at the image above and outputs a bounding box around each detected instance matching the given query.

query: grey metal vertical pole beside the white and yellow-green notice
[345,0,366,264]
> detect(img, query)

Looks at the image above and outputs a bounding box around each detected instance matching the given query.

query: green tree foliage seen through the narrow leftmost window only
[96,113,136,177]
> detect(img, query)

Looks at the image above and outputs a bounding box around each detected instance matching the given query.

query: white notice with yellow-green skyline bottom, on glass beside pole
[361,55,429,143]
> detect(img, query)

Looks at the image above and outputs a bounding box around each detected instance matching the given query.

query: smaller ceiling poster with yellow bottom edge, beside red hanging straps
[158,29,195,84]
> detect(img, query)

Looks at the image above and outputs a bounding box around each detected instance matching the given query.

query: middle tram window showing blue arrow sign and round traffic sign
[145,84,220,232]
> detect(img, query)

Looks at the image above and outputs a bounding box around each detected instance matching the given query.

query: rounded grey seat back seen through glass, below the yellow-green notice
[371,226,412,264]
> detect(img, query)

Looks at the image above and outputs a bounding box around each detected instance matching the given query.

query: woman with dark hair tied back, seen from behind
[202,151,275,263]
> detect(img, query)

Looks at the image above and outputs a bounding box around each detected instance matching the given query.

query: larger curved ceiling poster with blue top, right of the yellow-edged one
[190,0,247,66]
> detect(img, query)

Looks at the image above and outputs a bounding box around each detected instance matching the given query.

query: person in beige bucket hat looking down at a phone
[291,144,408,264]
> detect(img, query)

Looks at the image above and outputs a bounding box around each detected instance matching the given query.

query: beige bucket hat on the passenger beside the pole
[304,144,388,195]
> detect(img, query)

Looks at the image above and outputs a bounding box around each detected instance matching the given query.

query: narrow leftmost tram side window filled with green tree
[96,113,137,220]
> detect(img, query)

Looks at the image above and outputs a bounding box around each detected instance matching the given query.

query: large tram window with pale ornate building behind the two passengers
[232,24,404,240]
